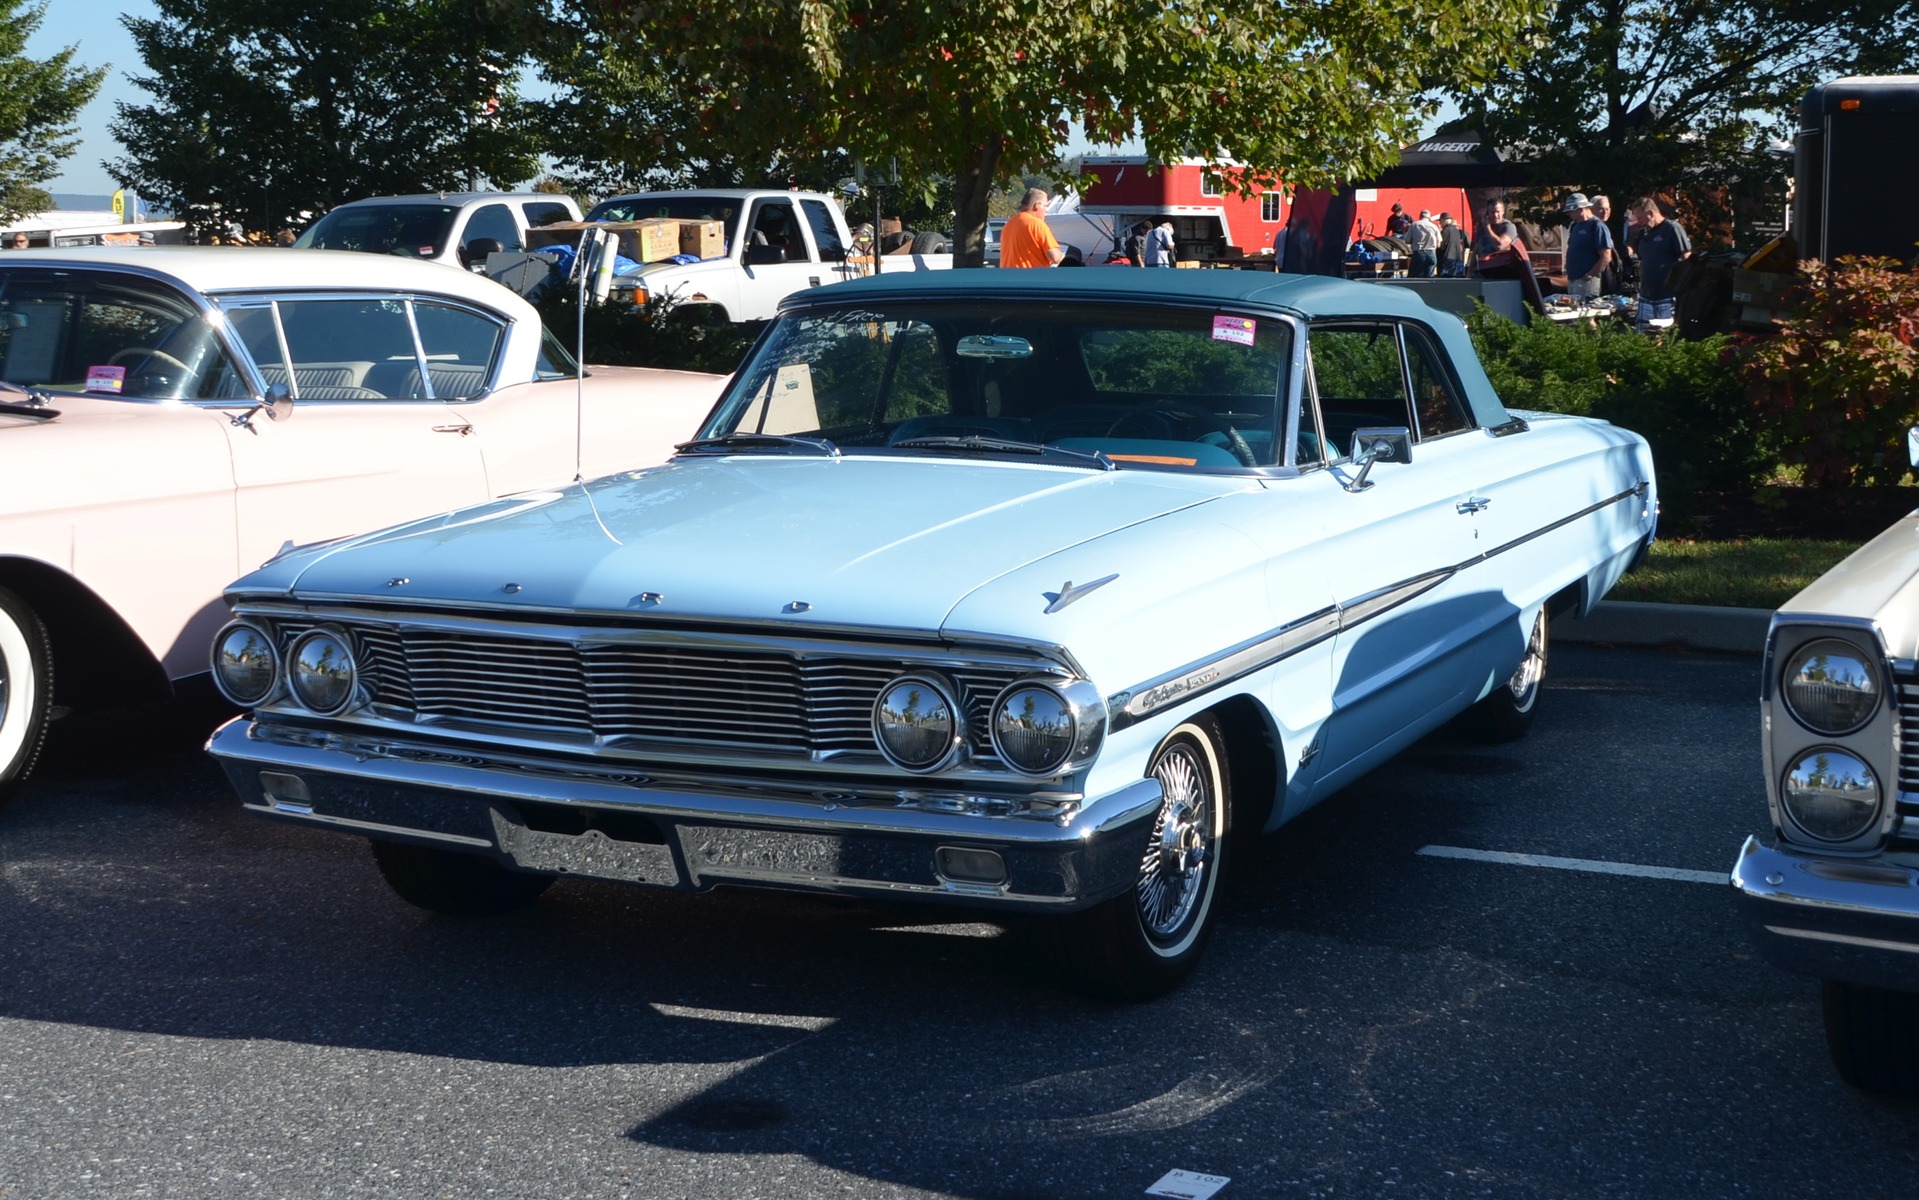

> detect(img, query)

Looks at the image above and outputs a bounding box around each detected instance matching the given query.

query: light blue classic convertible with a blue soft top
[211,269,1656,996]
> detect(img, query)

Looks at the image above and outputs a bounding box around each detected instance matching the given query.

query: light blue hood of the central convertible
[251,455,1259,632]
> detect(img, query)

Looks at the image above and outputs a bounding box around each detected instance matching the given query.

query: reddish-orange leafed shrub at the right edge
[1741,257,1919,488]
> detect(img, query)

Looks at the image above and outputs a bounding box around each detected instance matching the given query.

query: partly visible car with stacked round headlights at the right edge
[1731,515,1919,1092]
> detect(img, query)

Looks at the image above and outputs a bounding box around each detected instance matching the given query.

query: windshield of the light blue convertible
[702,301,1316,470]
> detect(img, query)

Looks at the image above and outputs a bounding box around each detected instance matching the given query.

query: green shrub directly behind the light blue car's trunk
[1466,305,1775,513]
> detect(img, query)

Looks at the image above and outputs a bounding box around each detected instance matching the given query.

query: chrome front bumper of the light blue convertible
[207,718,1161,912]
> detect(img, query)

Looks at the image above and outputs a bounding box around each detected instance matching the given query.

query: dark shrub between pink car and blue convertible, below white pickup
[535,290,766,374]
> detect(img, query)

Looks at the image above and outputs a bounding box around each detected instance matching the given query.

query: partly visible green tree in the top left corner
[0,0,107,221]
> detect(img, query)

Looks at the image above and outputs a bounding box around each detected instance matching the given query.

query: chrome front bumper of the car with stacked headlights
[1733,837,1919,991]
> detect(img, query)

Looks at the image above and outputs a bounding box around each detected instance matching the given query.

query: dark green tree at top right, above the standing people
[1445,0,1919,243]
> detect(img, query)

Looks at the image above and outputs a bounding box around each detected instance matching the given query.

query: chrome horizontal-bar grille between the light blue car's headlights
[278,620,1029,756]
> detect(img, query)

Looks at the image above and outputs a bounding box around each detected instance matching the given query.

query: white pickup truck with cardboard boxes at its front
[587,188,954,321]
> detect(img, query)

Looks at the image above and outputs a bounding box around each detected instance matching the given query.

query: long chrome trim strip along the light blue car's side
[1107,480,1648,732]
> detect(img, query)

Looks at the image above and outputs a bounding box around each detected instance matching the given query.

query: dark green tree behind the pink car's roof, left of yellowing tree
[107,0,539,240]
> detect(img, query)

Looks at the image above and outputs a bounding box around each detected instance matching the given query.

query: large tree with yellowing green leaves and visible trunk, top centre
[549,0,1543,265]
